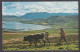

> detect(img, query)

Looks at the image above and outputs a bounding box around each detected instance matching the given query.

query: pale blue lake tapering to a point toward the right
[2,21,51,31]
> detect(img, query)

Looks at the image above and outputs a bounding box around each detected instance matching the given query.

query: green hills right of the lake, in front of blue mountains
[23,15,78,28]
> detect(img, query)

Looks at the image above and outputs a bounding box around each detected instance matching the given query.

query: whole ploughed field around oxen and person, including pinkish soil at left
[2,32,79,51]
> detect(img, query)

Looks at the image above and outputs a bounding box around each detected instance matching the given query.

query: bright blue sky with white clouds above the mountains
[2,1,78,16]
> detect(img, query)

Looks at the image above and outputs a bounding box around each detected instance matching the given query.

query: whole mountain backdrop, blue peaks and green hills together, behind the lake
[2,12,78,28]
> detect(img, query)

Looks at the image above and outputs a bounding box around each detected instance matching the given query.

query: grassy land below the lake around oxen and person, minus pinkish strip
[2,28,79,51]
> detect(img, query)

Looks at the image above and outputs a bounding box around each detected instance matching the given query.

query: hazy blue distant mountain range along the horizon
[3,12,78,19]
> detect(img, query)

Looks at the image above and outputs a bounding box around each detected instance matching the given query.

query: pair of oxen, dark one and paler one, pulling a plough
[23,32,50,47]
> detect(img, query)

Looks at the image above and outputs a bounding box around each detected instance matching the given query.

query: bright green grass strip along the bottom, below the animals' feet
[3,41,79,51]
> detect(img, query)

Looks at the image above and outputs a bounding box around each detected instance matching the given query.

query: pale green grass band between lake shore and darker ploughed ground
[2,28,78,40]
